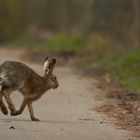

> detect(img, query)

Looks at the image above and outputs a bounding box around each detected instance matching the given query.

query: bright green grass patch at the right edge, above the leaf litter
[112,48,140,89]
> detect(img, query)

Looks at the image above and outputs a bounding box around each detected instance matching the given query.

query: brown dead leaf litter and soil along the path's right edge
[96,79,140,137]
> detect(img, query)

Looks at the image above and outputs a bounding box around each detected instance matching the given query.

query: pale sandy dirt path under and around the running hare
[0,49,137,140]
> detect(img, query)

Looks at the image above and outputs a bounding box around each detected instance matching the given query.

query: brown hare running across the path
[0,57,59,121]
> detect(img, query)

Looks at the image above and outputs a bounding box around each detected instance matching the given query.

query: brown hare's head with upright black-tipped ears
[44,57,59,89]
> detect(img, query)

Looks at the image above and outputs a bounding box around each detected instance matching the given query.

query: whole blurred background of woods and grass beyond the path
[0,0,140,90]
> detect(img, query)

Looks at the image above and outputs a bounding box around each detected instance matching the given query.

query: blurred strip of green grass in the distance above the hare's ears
[11,34,87,51]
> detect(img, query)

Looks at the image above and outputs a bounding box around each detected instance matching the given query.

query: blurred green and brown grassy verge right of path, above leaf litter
[77,36,140,92]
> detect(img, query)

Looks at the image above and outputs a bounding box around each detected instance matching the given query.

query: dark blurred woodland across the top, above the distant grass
[0,0,140,46]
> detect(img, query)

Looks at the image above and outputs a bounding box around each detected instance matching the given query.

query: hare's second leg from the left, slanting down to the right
[4,92,16,115]
